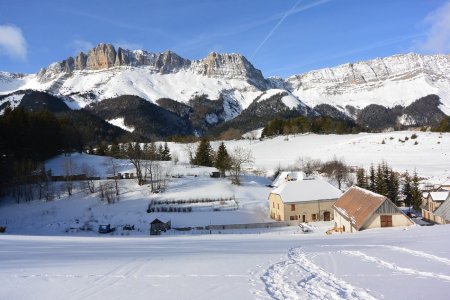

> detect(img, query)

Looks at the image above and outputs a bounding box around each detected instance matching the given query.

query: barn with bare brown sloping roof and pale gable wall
[333,186,414,232]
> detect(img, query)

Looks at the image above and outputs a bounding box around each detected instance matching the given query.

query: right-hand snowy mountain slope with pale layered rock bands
[284,53,450,115]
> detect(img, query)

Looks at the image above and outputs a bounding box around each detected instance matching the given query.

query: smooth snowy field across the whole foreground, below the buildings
[0,226,450,299]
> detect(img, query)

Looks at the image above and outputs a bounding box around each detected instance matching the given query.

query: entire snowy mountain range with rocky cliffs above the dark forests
[0,44,450,120]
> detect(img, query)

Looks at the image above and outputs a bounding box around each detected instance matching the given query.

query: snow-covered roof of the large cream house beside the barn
[272,179,342,203]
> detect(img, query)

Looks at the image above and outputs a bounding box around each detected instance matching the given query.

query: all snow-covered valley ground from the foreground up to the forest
[0,132,450,299]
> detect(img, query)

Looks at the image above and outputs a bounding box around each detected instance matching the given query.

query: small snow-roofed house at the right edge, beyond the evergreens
[422,190,450,224]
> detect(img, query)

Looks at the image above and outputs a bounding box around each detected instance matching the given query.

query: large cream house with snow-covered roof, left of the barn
[269,179,342,222]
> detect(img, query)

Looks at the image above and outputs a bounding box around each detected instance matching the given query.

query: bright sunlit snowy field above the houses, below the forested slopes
[169,131,450,183]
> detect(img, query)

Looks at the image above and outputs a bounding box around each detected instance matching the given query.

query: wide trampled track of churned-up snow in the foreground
[261,248,375,300]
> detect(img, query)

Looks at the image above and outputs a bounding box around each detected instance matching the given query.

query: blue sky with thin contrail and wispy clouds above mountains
[0,0,450,77]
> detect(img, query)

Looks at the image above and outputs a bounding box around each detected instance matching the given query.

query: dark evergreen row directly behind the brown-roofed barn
[356,162,422,211]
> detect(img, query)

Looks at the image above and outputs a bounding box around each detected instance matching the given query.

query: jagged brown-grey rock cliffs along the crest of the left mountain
[38,44,267,88]
